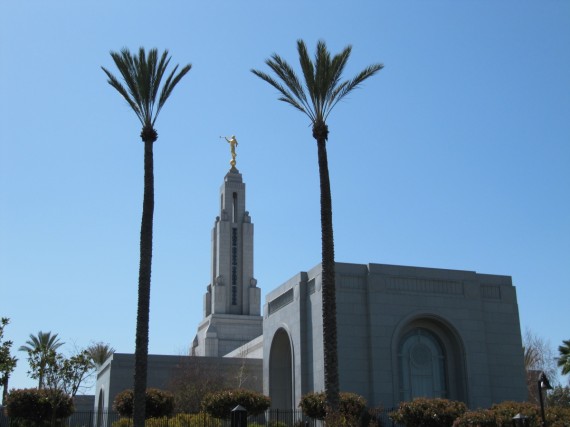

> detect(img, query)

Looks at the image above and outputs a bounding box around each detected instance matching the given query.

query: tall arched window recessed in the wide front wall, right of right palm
[398,328,447,401]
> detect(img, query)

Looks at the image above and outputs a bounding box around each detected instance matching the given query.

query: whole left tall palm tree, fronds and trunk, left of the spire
[101,47,192,427]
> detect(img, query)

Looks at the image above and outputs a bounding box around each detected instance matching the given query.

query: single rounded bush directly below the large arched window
[390,398,467,427]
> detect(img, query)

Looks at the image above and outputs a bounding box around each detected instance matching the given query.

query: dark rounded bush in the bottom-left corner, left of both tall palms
[6,388,74,423]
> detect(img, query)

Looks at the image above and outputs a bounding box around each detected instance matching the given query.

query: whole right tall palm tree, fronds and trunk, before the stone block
[251,40,383,411]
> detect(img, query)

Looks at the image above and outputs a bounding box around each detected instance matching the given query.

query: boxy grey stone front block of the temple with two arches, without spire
[263,263,526,408]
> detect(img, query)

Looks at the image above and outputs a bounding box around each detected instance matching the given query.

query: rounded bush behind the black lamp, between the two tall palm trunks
[202,389,271,419]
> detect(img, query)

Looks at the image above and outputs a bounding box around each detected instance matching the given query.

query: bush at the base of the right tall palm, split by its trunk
[299,391,366,425]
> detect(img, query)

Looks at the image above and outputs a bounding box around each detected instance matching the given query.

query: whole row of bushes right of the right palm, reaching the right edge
[390,398,570,427]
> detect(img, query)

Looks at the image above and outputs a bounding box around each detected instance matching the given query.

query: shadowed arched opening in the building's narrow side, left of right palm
[269,328,293,410]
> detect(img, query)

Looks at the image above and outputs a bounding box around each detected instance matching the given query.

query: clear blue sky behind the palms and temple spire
[0,0,570,394]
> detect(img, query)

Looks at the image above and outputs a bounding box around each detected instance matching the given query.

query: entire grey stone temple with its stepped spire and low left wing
[95,165,527,416]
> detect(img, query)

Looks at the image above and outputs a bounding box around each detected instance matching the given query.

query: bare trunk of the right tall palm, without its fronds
[313,123,339,412]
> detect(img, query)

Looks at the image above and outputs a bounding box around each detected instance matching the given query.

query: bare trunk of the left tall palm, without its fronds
[133,137,152,427]
